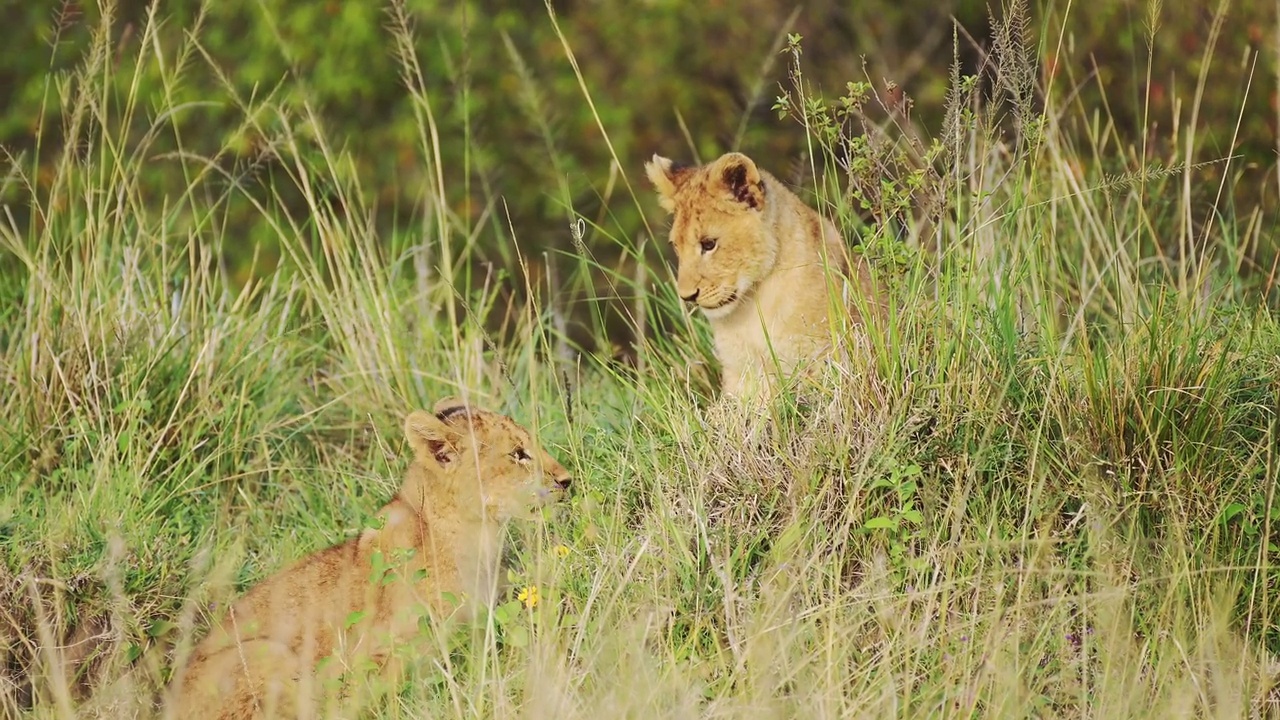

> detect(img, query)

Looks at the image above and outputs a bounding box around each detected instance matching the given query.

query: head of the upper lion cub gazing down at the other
[645,152,778,319]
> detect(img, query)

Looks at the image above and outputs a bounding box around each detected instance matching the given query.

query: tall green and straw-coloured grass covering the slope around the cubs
[0,2,1280,717]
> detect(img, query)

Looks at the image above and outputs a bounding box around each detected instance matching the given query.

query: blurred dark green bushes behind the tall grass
[0,0,1280,292]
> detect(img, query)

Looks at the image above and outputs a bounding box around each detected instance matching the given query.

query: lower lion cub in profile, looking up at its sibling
[169,398,570,720]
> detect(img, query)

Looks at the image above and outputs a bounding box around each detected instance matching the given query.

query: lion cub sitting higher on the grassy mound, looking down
[645,152,881,397]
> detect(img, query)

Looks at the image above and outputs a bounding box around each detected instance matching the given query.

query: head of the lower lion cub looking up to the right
[401,397,570,520]
